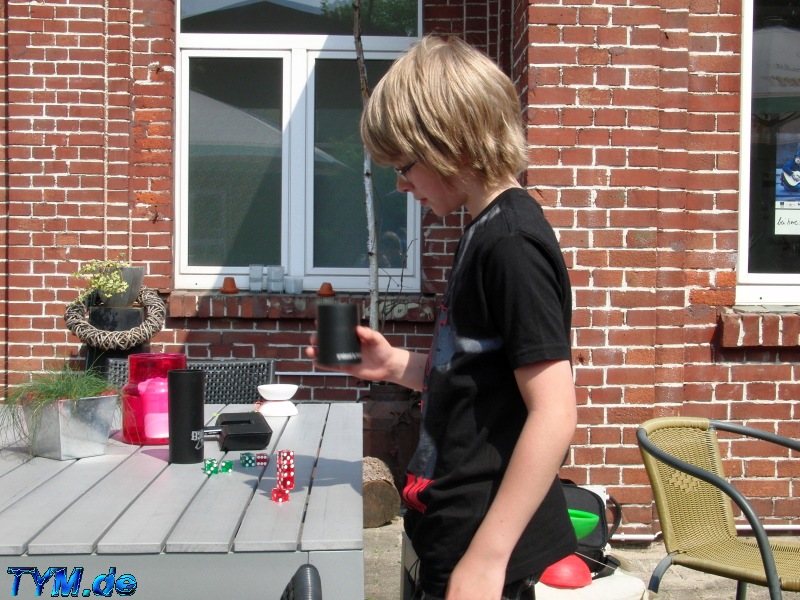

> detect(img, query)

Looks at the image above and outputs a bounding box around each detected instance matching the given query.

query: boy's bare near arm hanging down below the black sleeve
[447,360,577,600]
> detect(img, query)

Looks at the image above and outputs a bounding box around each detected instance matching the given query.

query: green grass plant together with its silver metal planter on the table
[5,364,119,460]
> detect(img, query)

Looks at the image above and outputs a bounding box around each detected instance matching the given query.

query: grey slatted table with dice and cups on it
[0,402,364,600]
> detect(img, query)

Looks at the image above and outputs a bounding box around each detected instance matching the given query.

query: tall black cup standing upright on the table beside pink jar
[167,369,206,464]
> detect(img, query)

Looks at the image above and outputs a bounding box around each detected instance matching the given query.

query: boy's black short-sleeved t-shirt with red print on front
[403,188,576,597]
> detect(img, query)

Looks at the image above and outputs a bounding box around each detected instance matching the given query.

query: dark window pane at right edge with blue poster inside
[748,0,800,273]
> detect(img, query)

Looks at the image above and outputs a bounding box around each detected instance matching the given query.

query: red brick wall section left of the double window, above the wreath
[2,1,174,384]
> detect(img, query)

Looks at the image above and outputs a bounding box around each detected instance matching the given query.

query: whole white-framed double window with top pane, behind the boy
[176,0,420,291]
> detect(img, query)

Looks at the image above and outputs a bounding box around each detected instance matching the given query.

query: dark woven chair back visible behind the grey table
[106,358,275,404]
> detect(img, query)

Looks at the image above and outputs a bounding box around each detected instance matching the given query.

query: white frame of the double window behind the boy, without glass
[175,31,422,292]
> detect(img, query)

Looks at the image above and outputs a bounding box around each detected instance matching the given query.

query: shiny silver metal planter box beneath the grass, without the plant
[23,396,119,460]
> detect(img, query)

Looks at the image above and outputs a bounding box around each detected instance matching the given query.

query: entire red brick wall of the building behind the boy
[0,0,800,533]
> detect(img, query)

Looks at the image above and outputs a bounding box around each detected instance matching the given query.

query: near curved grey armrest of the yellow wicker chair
[636,421,782,598]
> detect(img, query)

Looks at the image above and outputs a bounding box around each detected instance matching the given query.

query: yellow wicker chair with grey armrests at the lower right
[636,417,800,600]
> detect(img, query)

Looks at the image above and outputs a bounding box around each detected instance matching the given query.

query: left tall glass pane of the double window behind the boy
[188,57,282,267]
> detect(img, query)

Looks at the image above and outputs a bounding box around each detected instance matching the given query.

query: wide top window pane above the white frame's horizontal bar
[181,0,418,37]
